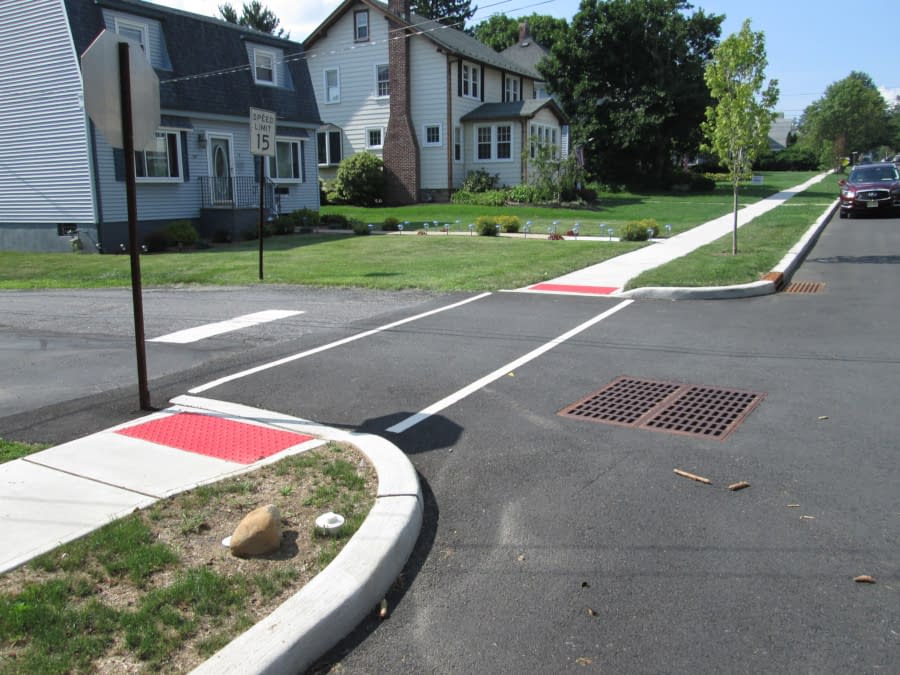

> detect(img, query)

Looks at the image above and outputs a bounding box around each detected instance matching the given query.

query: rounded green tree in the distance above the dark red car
[800,71,892,168]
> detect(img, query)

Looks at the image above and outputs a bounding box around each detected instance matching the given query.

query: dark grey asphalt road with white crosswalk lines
[0,210,900,673]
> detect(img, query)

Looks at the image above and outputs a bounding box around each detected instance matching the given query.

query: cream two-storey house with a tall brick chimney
[303,0,567,204]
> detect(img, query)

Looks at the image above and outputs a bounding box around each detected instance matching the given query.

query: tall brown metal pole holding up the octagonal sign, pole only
[119,42,153,410]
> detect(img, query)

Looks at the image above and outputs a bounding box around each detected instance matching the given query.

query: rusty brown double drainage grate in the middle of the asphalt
[559,376,765,440]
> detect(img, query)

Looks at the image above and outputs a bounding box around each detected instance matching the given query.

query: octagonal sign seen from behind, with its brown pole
[81,31,159,410]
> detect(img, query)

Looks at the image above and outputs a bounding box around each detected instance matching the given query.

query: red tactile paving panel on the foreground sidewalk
[116,413,313,464]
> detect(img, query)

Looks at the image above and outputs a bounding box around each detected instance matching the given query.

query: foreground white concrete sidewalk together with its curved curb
[0,396,422,675]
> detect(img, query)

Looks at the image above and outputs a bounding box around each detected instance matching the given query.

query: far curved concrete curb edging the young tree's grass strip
[612,199,840,300]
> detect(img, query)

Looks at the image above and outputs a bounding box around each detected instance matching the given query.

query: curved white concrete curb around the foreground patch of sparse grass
[171,396,423,675]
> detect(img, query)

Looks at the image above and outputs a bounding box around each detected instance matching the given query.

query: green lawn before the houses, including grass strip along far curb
[0,172,834,291]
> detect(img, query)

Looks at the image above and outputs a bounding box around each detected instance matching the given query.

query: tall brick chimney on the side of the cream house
[382,0,419,205]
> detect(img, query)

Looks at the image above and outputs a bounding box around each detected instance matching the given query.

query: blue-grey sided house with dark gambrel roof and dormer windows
[0,0,321,252]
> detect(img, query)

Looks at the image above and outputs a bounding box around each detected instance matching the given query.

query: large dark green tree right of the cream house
[539,0,724,186]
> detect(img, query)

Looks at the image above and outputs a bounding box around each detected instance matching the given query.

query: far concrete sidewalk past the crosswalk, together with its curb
[518,172,837,300]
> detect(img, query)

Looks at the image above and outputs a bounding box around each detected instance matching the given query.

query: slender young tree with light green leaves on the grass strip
[702,19,778,255]
